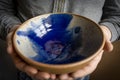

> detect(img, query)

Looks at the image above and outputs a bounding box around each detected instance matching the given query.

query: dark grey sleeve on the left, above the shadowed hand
[0,0,21,39]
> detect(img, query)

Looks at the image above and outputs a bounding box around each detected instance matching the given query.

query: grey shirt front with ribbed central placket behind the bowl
[17,0,105,22]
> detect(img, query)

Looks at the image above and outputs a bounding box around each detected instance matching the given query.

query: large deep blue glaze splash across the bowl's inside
[17,14,84,64]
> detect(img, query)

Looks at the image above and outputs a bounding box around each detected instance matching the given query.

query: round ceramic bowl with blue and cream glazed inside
[13,13,105,74]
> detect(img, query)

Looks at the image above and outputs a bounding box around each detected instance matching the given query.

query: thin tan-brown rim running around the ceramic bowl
[13,12,105,72]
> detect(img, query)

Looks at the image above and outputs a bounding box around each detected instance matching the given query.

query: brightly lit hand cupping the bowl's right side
[54,26,113,80]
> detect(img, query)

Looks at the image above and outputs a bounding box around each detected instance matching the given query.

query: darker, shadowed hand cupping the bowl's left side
[7,25,56,80]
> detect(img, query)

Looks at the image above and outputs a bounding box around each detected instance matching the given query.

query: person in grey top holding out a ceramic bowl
[0,0,120,80]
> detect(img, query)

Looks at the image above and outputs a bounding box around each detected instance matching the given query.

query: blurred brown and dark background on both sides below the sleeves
[0,40,120,80]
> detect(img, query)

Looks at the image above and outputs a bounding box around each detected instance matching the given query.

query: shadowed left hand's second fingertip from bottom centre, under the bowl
[34,71,50,80]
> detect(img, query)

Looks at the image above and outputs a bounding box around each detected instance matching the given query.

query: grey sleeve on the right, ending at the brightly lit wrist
[100,0,120,41]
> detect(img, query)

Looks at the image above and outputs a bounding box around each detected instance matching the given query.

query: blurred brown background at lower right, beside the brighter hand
[91,40,120,80]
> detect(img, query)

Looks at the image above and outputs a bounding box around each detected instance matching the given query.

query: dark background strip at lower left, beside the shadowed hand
[0,40,17,80]
